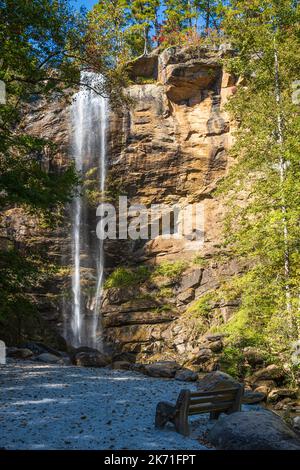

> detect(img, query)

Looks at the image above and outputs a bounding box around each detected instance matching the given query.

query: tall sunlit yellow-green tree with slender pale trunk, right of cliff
[218,0,300,368]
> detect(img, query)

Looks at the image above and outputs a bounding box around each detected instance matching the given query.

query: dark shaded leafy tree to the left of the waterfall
[0,0,126,338]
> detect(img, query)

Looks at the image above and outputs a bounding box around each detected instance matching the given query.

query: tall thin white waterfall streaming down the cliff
[66,72,108,349]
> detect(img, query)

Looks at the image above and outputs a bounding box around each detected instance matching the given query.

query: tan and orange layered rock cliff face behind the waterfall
[2,47,240,370]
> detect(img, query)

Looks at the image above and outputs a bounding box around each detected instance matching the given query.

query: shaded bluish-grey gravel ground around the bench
[0,361,209,450]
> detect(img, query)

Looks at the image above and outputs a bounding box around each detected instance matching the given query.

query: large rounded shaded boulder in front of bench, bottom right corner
[208,410,300,450]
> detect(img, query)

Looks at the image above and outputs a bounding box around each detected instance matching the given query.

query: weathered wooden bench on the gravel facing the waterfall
[155,384,244,436]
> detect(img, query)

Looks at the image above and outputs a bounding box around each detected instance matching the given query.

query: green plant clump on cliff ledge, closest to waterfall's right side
[104,266,150,289]
